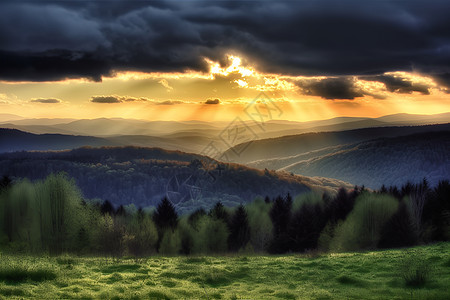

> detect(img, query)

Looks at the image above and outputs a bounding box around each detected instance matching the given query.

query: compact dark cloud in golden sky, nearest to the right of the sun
[297,77,364,100]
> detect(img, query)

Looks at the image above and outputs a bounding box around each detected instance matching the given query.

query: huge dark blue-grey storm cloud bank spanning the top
[0,0,450,82]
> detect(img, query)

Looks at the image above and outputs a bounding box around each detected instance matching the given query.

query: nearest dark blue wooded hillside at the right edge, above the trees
[249,130,450,189]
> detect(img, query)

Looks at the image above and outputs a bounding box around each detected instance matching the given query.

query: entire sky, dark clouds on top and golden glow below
[0,0,450,121]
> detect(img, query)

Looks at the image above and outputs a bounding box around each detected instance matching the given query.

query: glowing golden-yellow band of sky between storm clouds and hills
[0,56,450,121]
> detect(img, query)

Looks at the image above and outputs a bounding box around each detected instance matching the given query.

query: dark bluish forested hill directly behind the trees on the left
[0,147,349,211]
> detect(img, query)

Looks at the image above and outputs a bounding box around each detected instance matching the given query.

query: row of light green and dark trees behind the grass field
[0,173,450,258]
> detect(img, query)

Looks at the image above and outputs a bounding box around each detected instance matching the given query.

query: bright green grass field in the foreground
[0,243,450,299]
